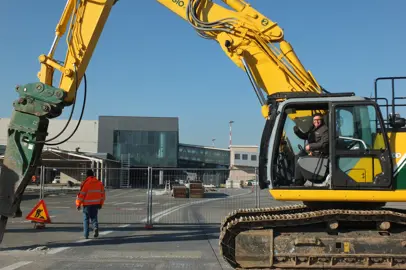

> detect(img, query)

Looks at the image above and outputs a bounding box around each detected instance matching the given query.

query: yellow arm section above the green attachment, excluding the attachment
[38,0,117,105]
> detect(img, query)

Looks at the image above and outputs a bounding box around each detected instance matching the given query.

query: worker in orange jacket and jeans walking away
[76,170,106,239]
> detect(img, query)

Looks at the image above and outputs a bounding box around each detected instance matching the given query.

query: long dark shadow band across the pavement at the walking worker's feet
[0,226,219,251]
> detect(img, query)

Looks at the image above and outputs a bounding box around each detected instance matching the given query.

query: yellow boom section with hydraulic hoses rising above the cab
[157,0,321,116]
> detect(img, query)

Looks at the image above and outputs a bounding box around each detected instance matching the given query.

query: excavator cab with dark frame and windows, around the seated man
[260,93,396,193]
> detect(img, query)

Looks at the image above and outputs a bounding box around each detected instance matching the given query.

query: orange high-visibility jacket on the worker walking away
[76,176,106,207]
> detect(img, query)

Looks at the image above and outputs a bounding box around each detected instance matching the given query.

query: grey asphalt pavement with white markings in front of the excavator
[0,188,284,270]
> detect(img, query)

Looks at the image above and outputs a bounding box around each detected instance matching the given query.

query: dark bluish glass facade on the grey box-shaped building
[113,130,178,167]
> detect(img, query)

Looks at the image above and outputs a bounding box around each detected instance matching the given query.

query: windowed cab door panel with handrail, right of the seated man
[329,101,393,189]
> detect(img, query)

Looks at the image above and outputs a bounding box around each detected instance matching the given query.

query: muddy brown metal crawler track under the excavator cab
[220,205,406,269]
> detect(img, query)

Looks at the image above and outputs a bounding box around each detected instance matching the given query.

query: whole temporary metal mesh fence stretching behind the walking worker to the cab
[27,167,268,227]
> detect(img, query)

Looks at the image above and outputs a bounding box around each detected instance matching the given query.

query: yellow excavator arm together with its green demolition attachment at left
[0,0,117,240]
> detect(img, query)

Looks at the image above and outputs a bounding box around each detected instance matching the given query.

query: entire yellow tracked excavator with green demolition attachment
[0,0,406,269]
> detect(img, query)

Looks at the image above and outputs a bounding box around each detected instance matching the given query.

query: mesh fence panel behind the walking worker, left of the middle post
[23,167,148,224]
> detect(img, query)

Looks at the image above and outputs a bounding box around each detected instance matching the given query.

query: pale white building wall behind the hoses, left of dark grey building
[0,118,99,153]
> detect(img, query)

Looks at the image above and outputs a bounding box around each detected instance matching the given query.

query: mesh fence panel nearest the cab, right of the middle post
[151,168,259,224]
